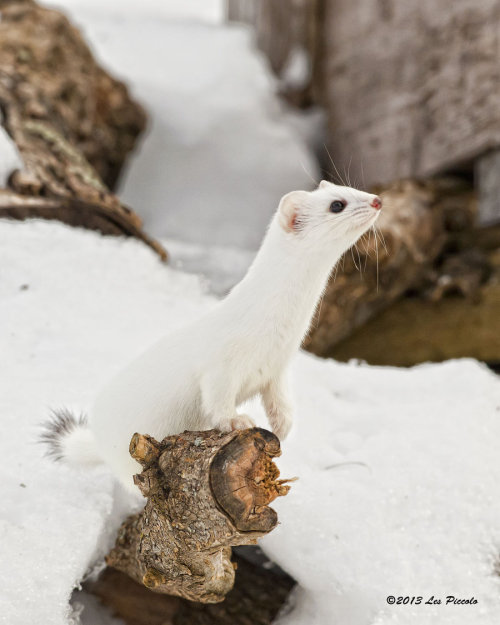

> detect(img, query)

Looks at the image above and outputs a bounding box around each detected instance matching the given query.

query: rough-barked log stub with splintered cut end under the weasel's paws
[106,428,290,603]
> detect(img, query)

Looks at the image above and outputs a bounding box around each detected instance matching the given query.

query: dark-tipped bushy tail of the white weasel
[39,408,104,467]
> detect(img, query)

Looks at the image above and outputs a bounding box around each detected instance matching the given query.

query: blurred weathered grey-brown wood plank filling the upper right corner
[321,0,500,185]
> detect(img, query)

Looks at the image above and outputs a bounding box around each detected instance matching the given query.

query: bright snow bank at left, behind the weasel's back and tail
[0,221,211,625]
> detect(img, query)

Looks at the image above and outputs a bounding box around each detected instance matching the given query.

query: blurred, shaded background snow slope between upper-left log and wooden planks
[48,0,319,249]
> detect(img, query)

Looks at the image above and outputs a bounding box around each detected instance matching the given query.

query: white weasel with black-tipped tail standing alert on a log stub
[44,181,382,488]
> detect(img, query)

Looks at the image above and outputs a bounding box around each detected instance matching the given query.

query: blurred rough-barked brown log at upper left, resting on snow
[0,0,166,258]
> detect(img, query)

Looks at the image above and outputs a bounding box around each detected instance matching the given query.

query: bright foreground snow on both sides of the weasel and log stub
[0,221,500,625]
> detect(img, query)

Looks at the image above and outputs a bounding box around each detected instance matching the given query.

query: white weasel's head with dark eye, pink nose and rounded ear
[278,180,382,249]
